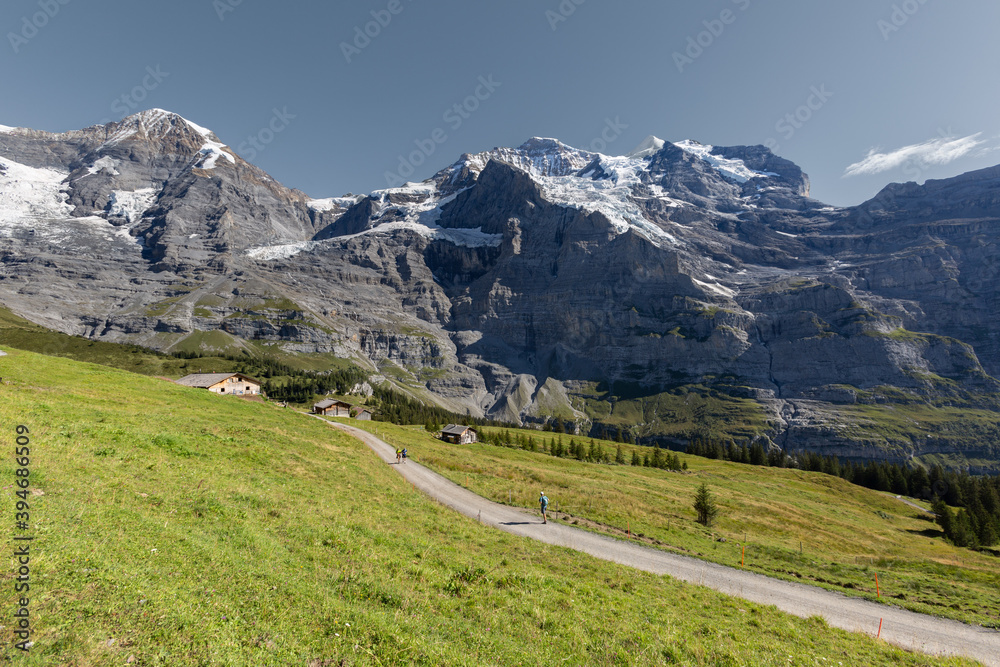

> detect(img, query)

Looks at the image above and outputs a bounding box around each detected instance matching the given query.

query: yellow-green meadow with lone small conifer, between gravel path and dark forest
[344,424,1000,628]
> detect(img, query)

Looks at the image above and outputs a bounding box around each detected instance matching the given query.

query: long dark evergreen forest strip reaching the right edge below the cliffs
[685,438,1000,548]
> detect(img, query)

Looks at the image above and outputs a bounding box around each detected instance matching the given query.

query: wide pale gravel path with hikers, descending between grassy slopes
[324,420,1000,667]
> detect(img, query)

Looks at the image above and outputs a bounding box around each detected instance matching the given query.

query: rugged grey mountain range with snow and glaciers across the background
[0,110,1000,470]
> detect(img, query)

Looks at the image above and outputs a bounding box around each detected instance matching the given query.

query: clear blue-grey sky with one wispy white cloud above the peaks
[0,0,1000,205]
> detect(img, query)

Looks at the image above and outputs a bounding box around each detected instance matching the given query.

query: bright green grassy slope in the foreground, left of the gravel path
[0,348,970,666]
